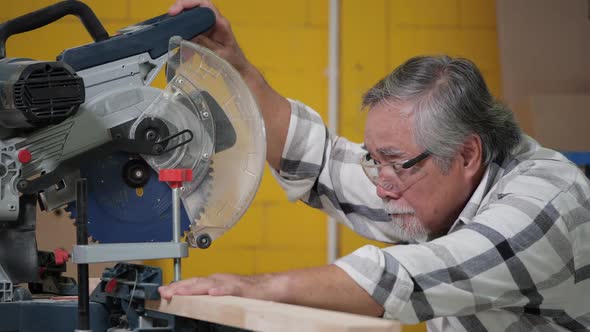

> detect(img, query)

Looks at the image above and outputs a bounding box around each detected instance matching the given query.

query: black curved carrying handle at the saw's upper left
[0,0,109,59]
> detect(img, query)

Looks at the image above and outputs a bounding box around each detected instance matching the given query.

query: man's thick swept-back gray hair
[362,56,521,171]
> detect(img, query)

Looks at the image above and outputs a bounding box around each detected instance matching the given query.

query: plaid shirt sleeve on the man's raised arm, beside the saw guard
[271,100,408,243]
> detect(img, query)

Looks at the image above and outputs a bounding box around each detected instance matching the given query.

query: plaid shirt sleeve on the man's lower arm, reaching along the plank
[335,195,573,323]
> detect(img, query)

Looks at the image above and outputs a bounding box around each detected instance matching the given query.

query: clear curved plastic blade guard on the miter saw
[130,38,266,248]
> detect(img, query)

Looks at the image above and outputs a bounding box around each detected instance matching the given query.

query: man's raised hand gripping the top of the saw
[168,0,254,76]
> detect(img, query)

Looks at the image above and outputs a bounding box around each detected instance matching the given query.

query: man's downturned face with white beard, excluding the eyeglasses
[365,102,472,240]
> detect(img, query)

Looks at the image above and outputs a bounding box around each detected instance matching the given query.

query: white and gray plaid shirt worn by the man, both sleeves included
[273,101,590,331]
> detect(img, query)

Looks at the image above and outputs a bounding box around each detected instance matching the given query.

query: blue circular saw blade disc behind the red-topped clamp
[68,153,190,243]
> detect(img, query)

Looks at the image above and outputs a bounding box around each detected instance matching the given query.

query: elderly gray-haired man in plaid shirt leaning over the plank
[160,0,590,331]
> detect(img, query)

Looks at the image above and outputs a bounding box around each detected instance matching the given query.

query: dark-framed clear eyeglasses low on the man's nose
[361,150,430,193]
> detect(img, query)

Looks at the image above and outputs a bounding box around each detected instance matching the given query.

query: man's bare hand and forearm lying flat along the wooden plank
[159,265,383,316]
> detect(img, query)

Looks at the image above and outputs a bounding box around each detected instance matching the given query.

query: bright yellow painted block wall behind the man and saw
[0,0,500,331]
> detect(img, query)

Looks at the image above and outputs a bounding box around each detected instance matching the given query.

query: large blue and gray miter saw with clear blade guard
[0,0,266,331]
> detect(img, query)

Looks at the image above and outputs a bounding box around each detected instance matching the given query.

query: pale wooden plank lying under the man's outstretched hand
[146,295,402,332]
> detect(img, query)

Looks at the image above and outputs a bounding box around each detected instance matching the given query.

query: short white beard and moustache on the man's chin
[383,199,430,242]
